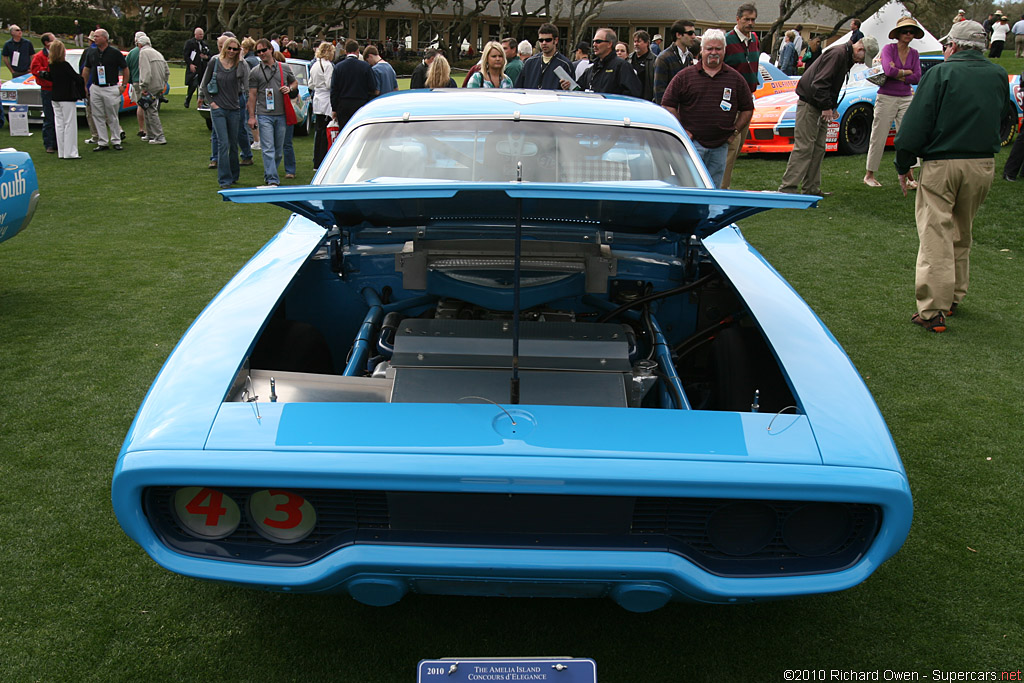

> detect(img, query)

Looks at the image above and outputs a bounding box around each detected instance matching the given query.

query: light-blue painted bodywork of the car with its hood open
[112,92,912,610]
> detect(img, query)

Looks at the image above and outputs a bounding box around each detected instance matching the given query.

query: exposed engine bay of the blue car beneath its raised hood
[227,237,796,411]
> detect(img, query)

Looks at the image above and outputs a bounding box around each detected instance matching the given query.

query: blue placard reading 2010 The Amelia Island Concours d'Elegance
[416,657,597,683]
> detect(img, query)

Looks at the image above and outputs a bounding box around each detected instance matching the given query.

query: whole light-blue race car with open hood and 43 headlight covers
[113,90,912,611]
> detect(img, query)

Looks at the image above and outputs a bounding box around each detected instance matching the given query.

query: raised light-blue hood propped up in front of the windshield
[220,178,820,237]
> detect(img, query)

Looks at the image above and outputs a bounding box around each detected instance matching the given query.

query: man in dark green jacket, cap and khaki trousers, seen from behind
[895,22,1015,332]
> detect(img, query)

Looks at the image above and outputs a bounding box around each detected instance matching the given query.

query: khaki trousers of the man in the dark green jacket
[914,159,995,321]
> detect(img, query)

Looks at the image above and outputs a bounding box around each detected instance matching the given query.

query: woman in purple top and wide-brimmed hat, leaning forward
[864,16,925,189]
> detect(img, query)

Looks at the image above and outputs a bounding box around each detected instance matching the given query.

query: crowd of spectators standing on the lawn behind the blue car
[2,3,1024,332]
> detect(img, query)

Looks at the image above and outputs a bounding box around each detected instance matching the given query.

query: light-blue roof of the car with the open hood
[350,88,682,132]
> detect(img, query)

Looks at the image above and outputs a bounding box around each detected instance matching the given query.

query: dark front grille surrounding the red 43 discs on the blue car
[143,486,882,577]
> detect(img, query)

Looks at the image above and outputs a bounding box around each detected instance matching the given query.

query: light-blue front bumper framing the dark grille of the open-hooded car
[113,452,911,611]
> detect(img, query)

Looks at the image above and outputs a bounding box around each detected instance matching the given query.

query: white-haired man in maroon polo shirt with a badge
[662,29,754,187]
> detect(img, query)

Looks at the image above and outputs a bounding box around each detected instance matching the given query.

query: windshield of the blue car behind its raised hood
[319,120,703,187]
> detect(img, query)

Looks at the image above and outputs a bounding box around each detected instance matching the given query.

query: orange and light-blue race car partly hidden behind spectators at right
[741,54,1024,155]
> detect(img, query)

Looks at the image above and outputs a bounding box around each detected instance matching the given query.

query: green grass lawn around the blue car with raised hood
[0,61,1024,682]
